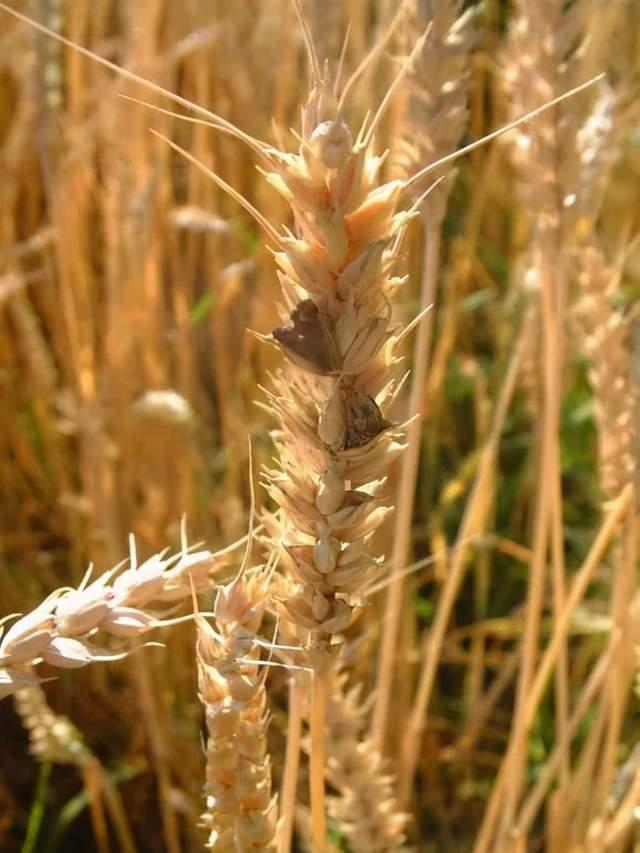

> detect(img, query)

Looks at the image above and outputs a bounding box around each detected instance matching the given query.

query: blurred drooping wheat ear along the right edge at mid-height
[577,245,635,499]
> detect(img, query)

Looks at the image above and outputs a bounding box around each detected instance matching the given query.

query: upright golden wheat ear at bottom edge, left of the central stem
[196,570,277,853]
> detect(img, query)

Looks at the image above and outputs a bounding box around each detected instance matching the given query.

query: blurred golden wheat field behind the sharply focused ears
[0,0,640,853]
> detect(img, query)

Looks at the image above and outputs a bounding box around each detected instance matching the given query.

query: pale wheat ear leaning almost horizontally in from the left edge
[0,548,224,698]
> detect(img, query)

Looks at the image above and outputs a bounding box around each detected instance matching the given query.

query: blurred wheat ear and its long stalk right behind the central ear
[372,0,475,748]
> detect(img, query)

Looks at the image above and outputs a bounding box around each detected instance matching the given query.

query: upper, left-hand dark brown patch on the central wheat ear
[272,299,340,376]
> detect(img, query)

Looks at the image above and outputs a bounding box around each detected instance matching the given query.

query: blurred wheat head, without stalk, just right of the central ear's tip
[394,0,477,216]
